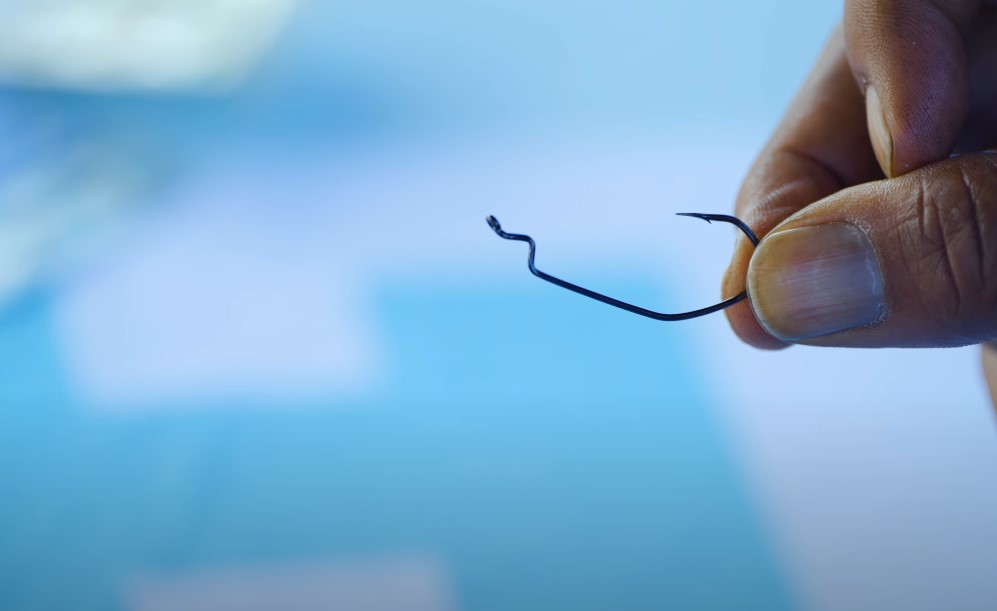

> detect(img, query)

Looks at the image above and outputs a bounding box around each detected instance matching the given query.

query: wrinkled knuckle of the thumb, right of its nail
[901,156,997,341]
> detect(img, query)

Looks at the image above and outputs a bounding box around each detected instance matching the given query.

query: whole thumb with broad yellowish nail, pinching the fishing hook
[748,153,997,347]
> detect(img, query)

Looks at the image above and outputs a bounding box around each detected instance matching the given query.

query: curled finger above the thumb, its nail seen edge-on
[845,0,980,176]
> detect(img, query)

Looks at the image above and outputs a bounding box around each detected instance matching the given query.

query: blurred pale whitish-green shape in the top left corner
[0,0,296,91]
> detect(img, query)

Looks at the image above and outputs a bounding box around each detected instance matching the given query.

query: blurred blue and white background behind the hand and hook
[0,0,997,611]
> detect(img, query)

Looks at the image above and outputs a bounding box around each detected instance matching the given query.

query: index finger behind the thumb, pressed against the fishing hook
[723,31,882,349]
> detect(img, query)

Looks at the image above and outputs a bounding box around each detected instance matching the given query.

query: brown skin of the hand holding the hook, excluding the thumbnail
[723,0,997,404]
